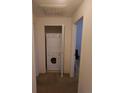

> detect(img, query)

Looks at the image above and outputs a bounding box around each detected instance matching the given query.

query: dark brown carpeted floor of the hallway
[37,73,78,93]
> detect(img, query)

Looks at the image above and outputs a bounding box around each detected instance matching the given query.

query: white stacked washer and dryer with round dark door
[46,28,62,72]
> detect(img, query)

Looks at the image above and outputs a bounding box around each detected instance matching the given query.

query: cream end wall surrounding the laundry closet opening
[34,17,72,73]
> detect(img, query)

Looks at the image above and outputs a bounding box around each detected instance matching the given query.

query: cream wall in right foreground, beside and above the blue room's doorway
[73,0,92,93]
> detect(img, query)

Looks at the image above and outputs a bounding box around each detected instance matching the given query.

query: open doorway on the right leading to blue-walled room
[70,17,83,77]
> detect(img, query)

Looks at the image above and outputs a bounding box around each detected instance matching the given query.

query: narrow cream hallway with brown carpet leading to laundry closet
[32,0,92,93]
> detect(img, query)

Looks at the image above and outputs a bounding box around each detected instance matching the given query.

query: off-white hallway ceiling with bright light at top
[33,0,82,17]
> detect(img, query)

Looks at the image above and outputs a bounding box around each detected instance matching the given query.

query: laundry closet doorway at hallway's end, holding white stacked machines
[45,25,64,76]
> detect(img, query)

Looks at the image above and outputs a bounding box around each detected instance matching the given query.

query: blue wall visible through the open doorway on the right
[76,19,83,55]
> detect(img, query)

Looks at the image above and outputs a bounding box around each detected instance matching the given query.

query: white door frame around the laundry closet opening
[44,24,65,77]
